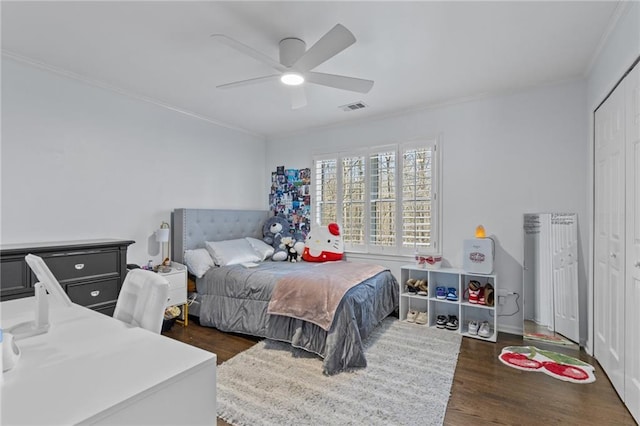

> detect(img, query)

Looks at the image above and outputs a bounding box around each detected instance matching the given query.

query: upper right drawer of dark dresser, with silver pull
[44,251,120,281]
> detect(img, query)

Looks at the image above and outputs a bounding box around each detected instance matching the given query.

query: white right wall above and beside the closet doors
[586,2,640,353]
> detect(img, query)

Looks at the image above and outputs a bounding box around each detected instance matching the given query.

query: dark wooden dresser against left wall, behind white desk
[0,239,135,316]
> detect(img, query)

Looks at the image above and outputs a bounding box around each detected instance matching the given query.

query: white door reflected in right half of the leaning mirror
[551,213,580,343]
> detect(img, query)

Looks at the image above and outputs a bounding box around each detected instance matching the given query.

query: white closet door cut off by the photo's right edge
[624,61,640,422]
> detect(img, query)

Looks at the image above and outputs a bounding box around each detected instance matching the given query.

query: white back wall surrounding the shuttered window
[267,80,587,333]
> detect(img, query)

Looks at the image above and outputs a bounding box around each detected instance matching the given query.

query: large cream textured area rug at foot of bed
[217,318,462,425]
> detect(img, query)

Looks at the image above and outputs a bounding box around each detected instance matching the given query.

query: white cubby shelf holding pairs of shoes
[399,265,498,342]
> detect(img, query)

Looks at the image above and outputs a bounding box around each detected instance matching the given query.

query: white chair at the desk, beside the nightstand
[113,269,169,333]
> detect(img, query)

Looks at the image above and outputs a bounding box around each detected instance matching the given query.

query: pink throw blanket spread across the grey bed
[267,262,387,331]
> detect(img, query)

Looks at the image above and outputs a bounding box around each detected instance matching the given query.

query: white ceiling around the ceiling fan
[1,1,619,136]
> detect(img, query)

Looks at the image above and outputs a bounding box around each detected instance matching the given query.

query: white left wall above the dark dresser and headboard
[0,57,268,263]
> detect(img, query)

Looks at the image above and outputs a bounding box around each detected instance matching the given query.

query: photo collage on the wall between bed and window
[269,166,311,237]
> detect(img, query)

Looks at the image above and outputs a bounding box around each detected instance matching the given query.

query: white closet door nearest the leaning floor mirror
[593,79,625,399]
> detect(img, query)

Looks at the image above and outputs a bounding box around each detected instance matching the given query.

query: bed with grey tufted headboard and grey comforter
[172,209,398,375]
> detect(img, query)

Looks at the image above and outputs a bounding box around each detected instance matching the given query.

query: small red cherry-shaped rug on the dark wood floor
[498,346,596,383]
